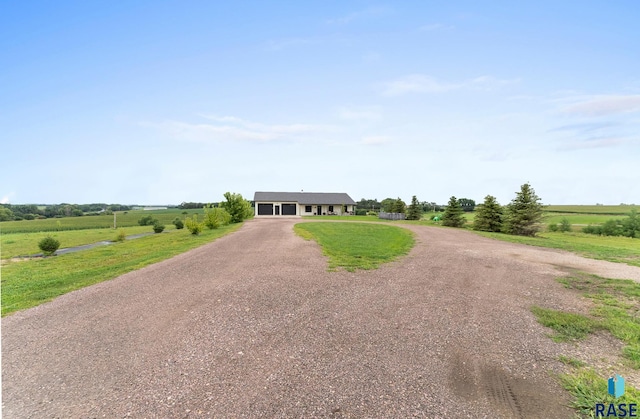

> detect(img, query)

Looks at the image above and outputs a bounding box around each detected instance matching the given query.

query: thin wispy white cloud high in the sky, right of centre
[382,74,520,96]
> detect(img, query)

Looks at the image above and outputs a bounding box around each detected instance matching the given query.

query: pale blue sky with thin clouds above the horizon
[0,0,640,205]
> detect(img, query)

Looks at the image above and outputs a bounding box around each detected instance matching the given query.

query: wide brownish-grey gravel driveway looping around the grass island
[2,219,640,418]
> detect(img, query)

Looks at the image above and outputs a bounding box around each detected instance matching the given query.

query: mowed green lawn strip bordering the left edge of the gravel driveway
[2,223,242,317]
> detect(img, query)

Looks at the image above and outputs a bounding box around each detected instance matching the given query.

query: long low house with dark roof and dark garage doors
[253,192,356,217]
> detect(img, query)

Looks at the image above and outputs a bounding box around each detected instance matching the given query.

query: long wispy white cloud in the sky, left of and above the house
[143,115,331,142]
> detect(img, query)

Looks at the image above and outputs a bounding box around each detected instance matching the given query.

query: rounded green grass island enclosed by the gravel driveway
[294,222,414,271]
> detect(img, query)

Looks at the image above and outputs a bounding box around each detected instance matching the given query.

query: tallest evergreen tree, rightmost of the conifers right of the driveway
[505,182,542,236]
